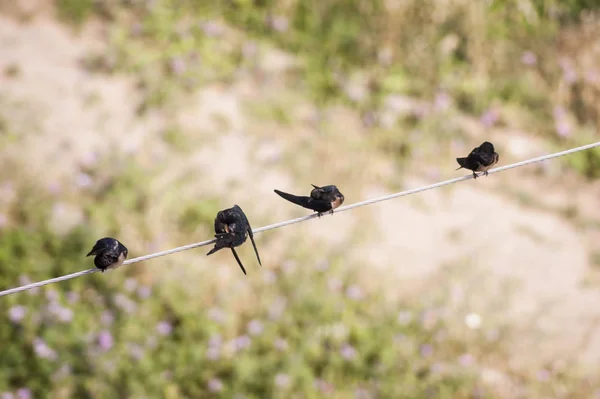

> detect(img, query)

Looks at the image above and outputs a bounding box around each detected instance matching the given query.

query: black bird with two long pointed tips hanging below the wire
[206,205,262,274]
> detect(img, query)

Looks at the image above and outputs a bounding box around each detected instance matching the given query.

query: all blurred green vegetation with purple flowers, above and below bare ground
[0,0,600,399]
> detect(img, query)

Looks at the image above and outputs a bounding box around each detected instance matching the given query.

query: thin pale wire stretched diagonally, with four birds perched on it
[0,142,600,296]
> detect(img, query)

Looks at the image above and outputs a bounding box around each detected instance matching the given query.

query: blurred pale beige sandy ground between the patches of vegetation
[0,13,600,382]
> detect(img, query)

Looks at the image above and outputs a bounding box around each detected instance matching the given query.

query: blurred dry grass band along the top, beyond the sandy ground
[58,0,600,178]
